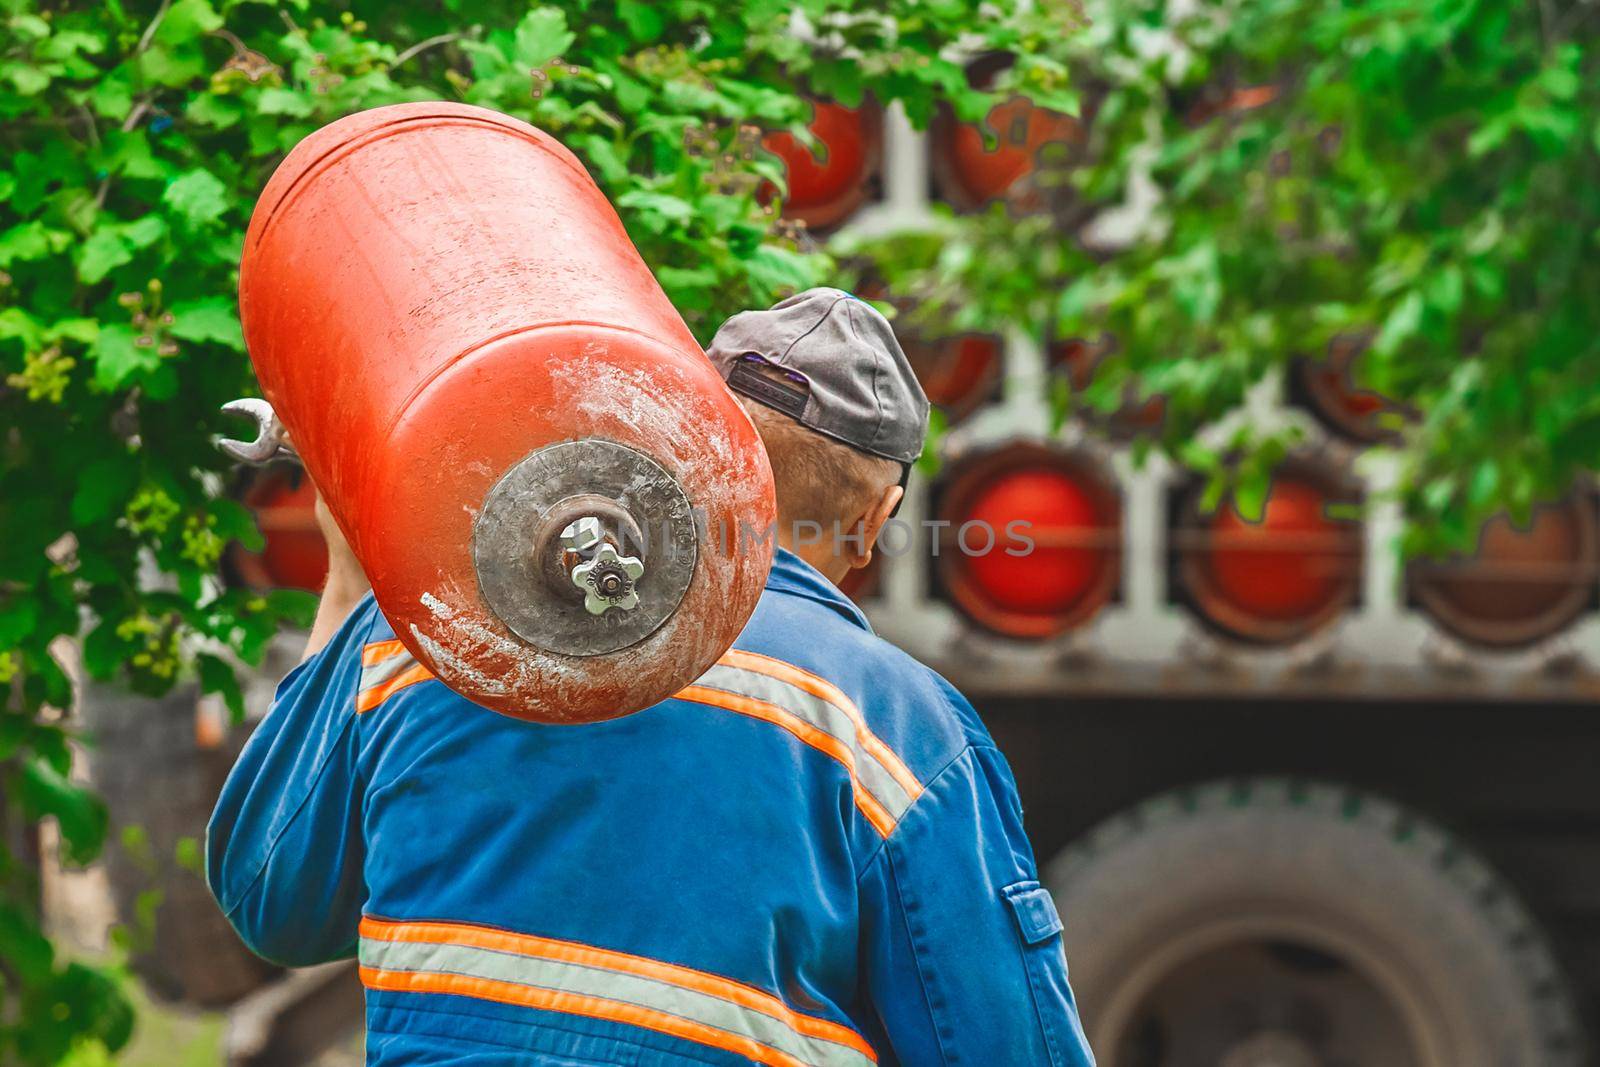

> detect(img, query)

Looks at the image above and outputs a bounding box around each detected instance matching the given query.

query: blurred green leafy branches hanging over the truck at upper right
[843,0,1600,553]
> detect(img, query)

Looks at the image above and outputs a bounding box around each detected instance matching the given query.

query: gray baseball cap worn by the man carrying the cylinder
[706,288,928,464]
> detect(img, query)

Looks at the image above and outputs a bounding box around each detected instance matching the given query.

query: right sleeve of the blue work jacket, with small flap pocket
[859,745,1094,1067]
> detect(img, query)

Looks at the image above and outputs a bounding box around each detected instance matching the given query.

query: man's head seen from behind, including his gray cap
[707,288,928,581]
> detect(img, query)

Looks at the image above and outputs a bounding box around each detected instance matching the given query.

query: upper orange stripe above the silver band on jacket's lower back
[360,917,877,1059]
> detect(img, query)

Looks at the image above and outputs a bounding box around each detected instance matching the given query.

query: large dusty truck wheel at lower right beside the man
[1046,779,1586,1067]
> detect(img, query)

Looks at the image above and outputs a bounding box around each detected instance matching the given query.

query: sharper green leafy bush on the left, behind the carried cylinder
[0,0,1077,1064]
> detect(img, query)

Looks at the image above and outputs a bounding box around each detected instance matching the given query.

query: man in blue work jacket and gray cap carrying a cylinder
[206,290,1093,1067]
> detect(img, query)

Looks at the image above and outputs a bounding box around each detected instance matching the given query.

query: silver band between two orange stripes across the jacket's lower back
[360,937,874,1067]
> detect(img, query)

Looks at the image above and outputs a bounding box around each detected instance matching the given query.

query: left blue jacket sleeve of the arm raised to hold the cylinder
[206,597,374,966]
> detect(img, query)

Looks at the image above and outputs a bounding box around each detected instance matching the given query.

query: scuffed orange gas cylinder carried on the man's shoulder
[238,102,773,721]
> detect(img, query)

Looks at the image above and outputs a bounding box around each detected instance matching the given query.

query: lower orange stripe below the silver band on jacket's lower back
[360,968,806,1067]
